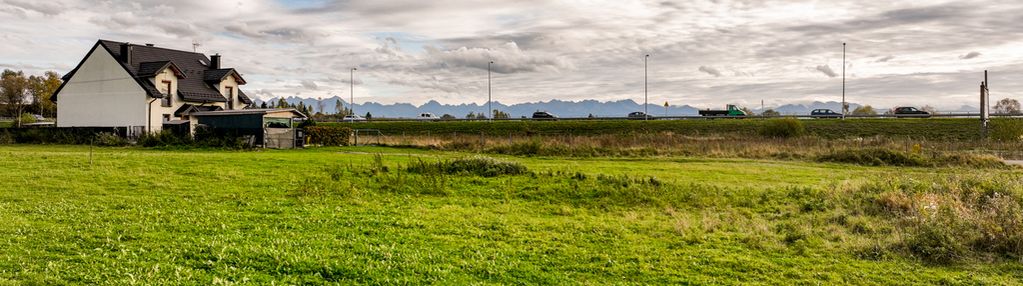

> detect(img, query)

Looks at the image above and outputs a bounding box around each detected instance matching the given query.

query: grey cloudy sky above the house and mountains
[0,0,1023,109]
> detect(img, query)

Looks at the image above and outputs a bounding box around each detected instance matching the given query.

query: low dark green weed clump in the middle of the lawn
[406,156,529,178]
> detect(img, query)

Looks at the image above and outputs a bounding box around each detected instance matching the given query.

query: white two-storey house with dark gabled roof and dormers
[51,40,252,133]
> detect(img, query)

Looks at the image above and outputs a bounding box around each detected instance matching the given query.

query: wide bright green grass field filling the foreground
[0,145,1023,285]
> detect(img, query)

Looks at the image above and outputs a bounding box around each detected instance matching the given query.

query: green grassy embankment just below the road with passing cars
[323,118,981,140]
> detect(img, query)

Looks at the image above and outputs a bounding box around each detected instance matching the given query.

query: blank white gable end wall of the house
[57,46,149,129]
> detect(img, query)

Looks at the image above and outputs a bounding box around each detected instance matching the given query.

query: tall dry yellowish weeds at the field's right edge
[861,175,1023,264]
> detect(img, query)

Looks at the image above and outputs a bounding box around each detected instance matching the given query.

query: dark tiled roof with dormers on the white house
[51,40,251,102]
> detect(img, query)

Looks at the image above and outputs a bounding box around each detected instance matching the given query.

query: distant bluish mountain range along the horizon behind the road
[254,96,977,118]
